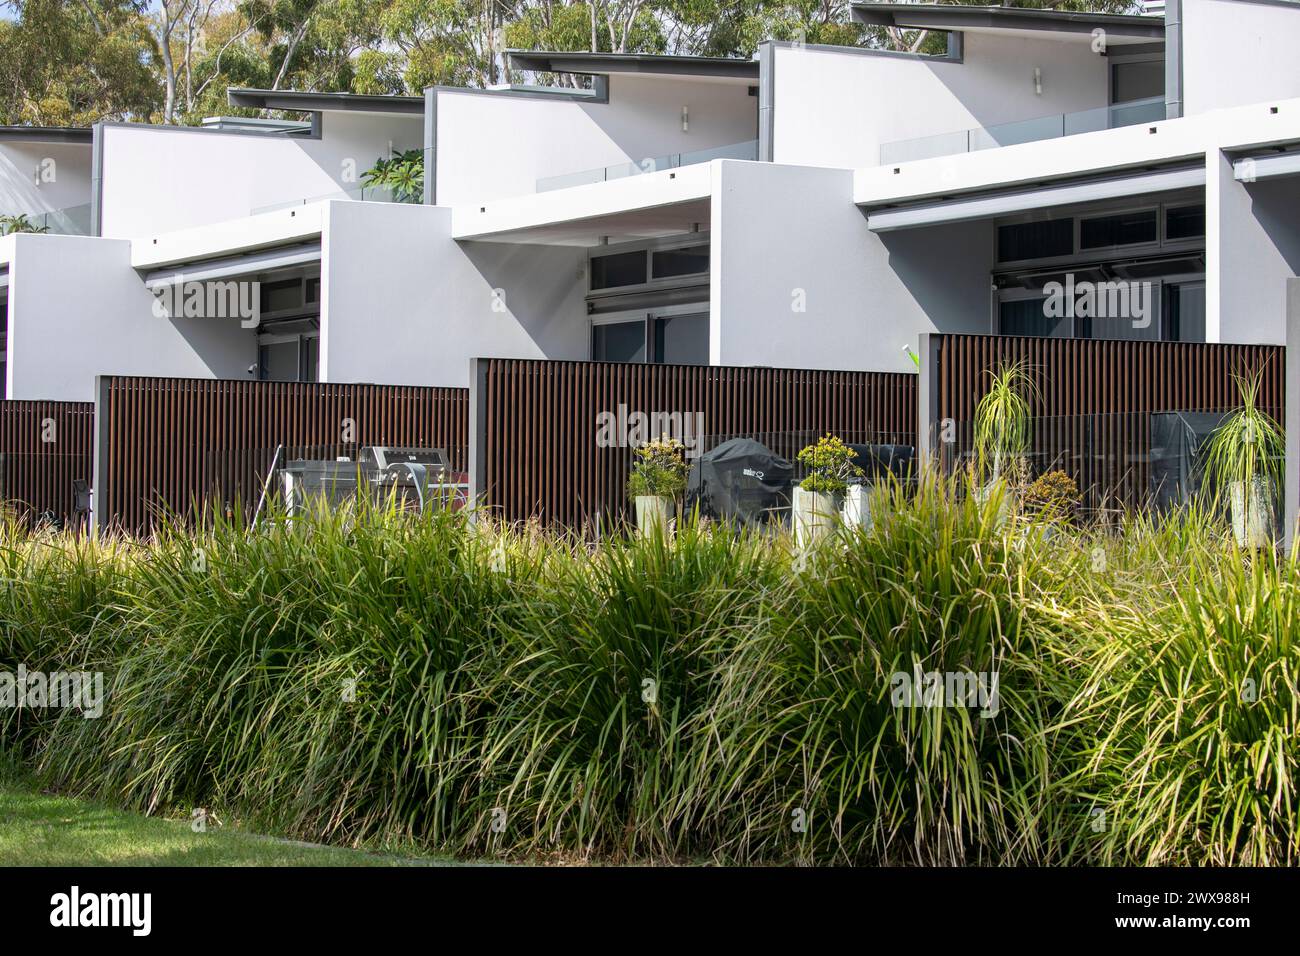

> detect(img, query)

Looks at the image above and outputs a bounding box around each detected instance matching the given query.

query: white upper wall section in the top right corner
[1182,0,1300,116]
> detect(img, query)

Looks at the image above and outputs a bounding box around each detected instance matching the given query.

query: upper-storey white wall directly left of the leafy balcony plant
[101,112,424,238]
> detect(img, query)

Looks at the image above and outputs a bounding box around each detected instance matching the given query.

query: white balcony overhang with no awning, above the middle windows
[451,160,728,247]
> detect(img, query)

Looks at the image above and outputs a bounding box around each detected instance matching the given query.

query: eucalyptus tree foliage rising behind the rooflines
[0,0,1136,126]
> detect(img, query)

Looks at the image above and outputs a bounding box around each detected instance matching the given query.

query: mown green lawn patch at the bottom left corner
[0,779,456,866]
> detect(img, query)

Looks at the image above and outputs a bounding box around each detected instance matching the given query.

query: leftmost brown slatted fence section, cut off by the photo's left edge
[0,401,95,523]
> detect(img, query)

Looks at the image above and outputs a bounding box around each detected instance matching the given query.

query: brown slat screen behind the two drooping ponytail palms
[922,334,1286,507]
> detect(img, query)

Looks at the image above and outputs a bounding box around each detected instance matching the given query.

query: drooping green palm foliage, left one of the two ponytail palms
[972,362,1034,523]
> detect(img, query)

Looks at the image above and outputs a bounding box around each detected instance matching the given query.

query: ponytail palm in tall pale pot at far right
[1205,373,1286,550]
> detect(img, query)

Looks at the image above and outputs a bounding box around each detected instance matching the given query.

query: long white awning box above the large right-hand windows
[867,166,1205,233]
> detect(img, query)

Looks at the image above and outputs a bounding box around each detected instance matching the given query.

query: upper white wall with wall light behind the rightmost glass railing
[772,34,1109,168]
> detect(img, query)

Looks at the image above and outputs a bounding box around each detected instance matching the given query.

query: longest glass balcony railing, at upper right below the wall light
[880,96,1165,166]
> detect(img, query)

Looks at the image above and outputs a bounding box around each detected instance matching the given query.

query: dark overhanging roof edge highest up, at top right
[852,3,1165,40]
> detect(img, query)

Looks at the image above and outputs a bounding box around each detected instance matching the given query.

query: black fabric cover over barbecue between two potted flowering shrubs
[686,438,794,525]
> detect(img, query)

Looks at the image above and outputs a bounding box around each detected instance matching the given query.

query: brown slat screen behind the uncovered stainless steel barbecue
[95,376,469,533]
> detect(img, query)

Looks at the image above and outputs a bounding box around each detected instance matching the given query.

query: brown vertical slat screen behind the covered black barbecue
[476,359,917,527]
